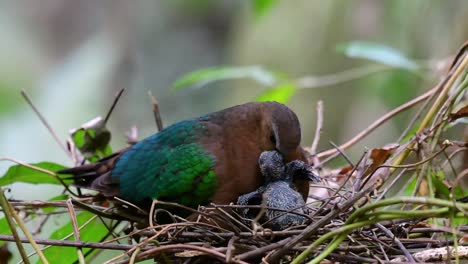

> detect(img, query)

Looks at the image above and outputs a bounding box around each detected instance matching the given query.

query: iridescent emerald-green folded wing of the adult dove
[111,119,216,206]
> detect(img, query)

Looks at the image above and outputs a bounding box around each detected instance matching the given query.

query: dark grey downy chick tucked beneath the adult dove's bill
[237,151,320,231]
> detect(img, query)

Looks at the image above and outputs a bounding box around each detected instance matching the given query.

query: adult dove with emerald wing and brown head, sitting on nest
[58,102,309,208]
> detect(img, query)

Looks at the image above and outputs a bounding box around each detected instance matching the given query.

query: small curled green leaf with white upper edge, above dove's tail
[70,117,112,162]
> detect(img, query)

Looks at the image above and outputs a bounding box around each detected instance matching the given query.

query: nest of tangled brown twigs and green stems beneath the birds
[0,42,468,263]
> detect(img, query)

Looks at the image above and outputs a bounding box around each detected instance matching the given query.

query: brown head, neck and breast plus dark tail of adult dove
[59,102,309,204]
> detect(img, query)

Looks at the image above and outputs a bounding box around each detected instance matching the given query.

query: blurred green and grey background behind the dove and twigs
[0,0,468,199]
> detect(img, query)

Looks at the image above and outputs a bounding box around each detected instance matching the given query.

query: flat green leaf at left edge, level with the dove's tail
[0,162,71,186]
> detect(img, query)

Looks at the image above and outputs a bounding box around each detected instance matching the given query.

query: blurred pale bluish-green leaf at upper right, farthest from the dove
[336,41,419,70]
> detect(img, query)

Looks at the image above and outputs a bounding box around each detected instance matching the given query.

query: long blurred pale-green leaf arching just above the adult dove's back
[172,66,278,91]
